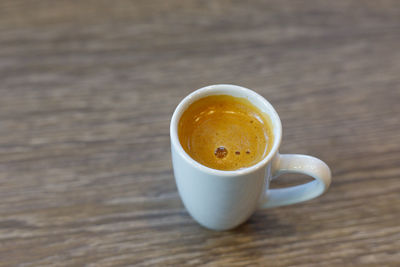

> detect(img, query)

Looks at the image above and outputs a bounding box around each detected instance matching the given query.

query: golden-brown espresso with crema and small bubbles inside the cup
[178,95,273,170]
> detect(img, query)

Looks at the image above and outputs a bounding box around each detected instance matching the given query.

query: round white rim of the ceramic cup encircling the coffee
[170,84,282,177]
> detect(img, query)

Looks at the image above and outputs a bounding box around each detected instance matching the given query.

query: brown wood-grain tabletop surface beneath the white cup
[0,0,400,267]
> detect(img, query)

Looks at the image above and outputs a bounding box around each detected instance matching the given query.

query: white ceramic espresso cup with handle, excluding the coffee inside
[170,84,331,230]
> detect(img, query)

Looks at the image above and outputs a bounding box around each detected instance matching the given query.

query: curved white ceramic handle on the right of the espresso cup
[261,154,331,208]
